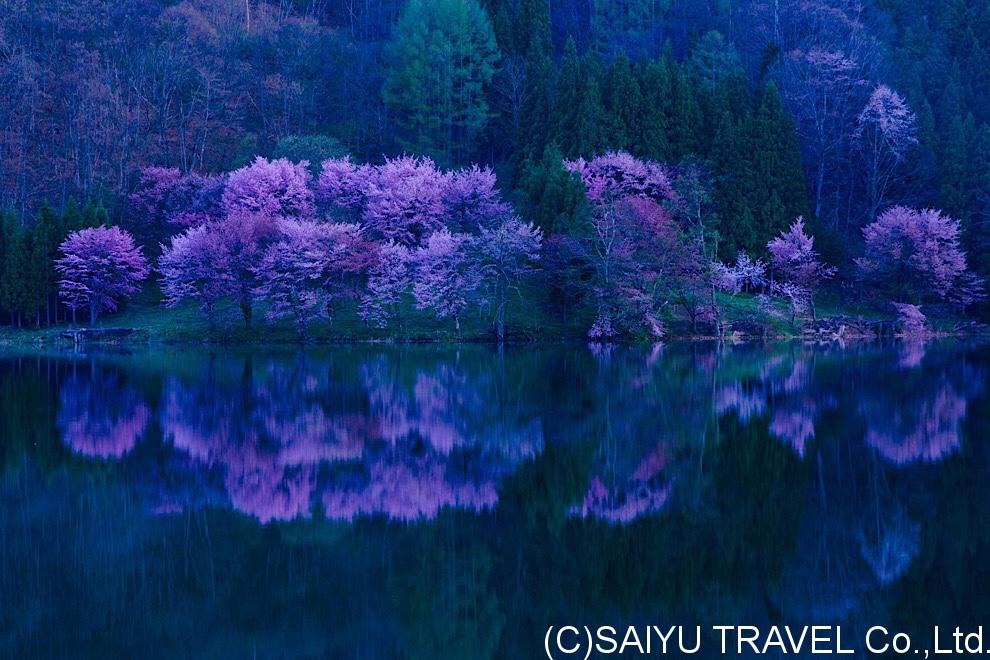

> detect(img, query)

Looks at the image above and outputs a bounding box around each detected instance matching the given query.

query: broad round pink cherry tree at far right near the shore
[857,206,982,304]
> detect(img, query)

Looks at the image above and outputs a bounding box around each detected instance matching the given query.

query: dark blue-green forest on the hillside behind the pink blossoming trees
[0,0,990,328]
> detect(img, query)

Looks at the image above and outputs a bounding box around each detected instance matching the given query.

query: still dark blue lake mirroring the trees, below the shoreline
[0,340,990,658]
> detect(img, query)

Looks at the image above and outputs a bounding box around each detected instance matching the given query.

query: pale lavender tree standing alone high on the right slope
[853,85,918,221]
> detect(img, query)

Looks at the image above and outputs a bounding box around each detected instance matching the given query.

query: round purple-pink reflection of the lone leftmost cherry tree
[58,376,151,458]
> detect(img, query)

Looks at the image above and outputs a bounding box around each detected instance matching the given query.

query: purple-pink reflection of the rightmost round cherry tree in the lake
[866,382,966,465]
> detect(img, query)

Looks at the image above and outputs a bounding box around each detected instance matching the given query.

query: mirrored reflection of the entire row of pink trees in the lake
[44,345,980,522]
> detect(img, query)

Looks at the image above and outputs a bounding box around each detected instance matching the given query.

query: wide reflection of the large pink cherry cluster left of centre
[155,356,542,522]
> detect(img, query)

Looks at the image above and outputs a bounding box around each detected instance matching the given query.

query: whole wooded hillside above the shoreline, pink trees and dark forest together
[0,0,990,337]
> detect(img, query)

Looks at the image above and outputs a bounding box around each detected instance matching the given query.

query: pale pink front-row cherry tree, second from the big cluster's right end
[413,228,479,334]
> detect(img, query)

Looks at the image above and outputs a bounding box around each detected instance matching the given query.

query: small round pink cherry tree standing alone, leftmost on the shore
[55,226,149,324]
